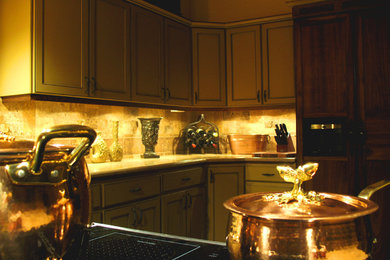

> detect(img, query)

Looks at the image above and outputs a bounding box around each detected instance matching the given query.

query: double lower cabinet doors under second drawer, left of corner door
[161,187,207,239]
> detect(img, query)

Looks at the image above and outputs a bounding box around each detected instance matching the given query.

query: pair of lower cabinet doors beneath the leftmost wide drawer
[104,197,161,232]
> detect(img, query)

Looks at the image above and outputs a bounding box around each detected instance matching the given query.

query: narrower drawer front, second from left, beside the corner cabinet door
[162,167,206,191]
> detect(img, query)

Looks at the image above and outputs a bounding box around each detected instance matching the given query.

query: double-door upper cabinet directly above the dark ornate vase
[131,7,192,105]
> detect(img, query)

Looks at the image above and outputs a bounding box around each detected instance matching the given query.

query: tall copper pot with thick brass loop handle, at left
[0,125,96,259]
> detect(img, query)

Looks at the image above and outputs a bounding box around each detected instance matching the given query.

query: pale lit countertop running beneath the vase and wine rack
[87,154,295,177]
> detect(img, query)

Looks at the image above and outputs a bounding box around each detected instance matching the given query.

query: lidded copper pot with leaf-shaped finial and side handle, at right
[224,164,390,260]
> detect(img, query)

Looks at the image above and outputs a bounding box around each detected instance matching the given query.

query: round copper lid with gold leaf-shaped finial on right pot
[224,163,378,222]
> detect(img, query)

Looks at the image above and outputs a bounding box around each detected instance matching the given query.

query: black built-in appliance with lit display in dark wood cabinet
[303,118,347,156]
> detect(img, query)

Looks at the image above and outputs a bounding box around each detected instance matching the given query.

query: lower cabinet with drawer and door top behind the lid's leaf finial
[245,163,295,193]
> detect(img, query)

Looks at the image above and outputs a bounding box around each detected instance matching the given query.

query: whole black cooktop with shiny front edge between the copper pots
[65,223,230,260]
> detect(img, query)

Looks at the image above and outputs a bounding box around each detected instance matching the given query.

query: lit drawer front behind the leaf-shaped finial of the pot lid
[245,163,295,182]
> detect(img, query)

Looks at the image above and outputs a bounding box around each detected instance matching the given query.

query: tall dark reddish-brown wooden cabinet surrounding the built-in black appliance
[293,1,390,259]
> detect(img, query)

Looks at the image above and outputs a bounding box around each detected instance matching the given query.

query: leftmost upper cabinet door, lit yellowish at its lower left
[35,0,88,96]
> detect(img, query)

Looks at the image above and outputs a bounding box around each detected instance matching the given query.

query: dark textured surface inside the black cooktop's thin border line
[86,232,200,260]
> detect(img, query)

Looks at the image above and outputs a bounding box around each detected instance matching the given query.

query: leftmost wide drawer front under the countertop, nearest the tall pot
[104,175,161,207]
